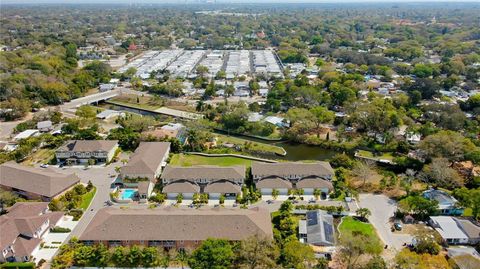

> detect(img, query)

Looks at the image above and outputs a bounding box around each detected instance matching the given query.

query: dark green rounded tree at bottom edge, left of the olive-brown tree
[188,238,235,269]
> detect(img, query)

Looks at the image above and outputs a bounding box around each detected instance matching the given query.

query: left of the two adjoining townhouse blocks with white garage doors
[161,165,245,199]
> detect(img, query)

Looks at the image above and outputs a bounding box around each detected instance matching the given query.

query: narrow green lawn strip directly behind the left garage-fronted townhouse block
[170,154,252,167]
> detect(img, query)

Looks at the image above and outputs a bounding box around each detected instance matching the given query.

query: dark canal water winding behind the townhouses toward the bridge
[100,103,338,161]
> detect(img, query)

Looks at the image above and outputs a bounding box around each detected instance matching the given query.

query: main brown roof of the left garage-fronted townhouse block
[161,165,245,181]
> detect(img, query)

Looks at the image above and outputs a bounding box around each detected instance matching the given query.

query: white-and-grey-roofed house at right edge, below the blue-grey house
[428,216,480,245]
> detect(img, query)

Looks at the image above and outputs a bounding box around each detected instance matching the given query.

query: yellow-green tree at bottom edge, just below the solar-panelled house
[282,239,316,269]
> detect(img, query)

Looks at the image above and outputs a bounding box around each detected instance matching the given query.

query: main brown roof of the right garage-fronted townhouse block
[252,162,333,178]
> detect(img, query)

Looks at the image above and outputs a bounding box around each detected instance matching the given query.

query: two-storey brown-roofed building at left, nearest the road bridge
[55,140,118,164]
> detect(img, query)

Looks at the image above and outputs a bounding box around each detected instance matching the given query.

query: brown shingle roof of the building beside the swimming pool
[120,142,170,179]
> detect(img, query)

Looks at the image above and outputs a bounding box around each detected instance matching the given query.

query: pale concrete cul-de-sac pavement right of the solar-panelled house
[359,194,412,250]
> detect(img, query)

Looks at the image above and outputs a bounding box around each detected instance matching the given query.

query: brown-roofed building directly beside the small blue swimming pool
[120,142,170,183]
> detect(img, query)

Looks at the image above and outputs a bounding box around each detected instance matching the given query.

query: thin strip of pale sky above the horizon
[0,0,480,4]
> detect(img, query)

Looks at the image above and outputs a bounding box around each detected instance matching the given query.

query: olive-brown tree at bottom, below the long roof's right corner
[236,236,280,269]
